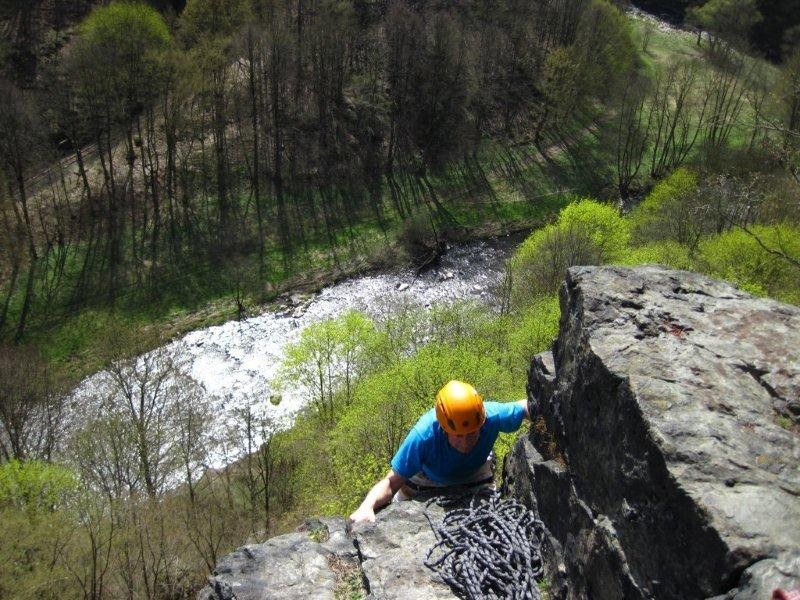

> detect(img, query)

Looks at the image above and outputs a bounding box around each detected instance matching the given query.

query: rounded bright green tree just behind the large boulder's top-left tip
[511,199,630,307]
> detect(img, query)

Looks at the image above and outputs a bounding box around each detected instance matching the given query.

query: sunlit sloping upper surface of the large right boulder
[568,267,800,558]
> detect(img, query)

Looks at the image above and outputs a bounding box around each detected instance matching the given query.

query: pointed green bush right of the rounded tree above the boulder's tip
[630,168,701,247]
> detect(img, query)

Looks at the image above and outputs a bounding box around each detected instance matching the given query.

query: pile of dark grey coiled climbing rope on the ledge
[425,489,544,600]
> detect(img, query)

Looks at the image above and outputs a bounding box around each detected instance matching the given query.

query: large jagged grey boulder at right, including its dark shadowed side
[506,267,800,600]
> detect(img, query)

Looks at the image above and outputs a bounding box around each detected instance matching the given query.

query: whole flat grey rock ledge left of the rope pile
[198,502,455,600]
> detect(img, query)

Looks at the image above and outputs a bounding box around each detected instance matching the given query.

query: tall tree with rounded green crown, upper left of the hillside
[67,2,171,298]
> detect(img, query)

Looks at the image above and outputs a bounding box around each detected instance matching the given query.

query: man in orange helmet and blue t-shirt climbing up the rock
[350,381,532,523]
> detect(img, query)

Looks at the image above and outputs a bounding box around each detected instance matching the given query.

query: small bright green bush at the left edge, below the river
[0,460,78,517]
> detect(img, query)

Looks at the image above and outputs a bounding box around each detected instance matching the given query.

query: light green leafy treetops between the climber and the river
[280,297,559,513]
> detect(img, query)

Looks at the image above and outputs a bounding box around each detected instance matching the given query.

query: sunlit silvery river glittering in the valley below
[68,236,520,467]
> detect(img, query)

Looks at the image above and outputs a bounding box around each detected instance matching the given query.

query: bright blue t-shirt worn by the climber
[392,402,525,484]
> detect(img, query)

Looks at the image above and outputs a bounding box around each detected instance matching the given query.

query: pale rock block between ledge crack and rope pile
[353,501,456,600]
